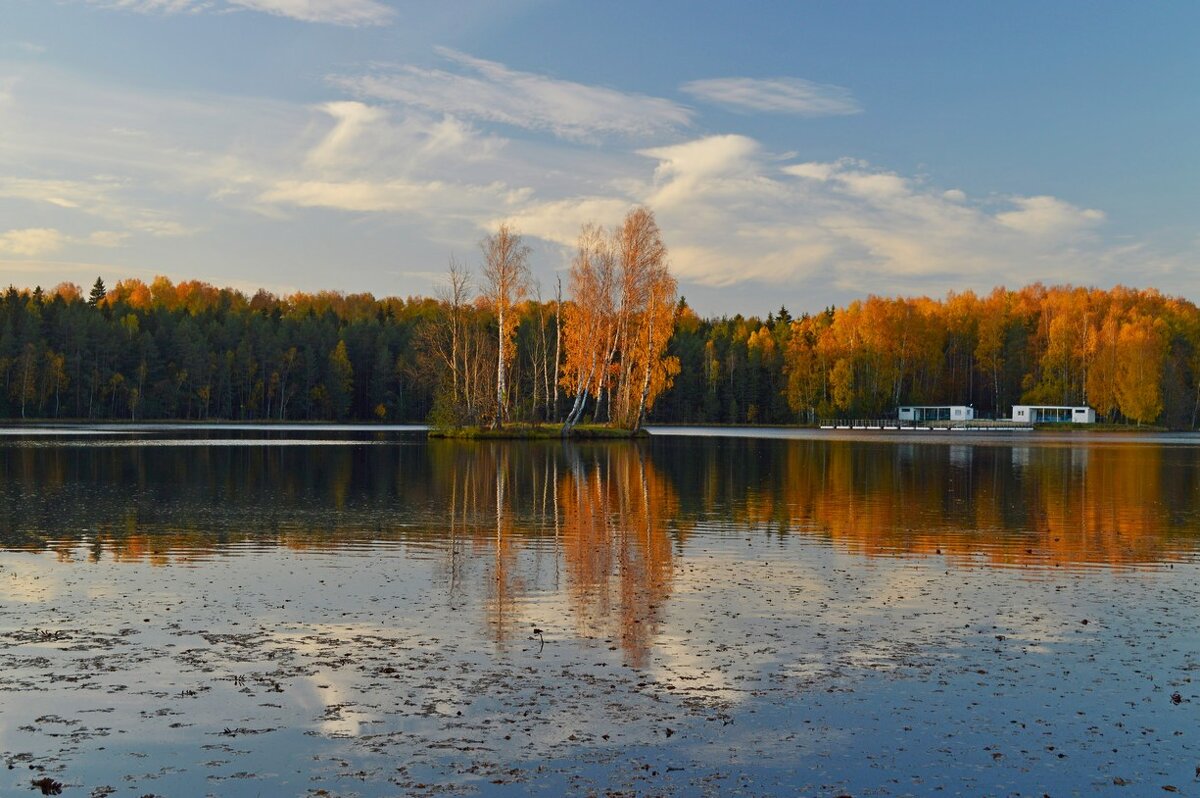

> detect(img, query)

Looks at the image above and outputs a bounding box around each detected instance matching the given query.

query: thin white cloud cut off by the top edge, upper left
[85,0,396,28]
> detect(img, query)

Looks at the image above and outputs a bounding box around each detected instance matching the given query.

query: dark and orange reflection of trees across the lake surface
[0,434,1200,666]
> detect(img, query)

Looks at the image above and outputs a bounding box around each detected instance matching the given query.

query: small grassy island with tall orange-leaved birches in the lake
[426,208,679,439]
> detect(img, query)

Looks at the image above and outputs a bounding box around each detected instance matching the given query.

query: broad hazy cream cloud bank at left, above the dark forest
[0,64,526,251]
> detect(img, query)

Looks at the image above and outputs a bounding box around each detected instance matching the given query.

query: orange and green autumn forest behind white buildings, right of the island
[656,284,1200,428]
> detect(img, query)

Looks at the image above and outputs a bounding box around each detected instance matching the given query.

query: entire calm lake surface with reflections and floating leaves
[0,427,1200,796]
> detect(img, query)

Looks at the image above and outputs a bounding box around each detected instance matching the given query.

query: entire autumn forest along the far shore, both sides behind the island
[0,277,1200,428]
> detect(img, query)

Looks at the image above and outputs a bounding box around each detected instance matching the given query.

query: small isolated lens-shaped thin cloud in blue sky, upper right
[683,78,863,116]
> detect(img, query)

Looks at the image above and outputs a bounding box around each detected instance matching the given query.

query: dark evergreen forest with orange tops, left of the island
[0,277,439,420]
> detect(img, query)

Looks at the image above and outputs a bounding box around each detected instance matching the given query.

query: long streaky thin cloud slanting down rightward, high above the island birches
[331,48,692,140]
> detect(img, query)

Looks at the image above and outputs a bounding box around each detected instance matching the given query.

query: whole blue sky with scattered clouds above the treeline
[0,0,1200,313]
